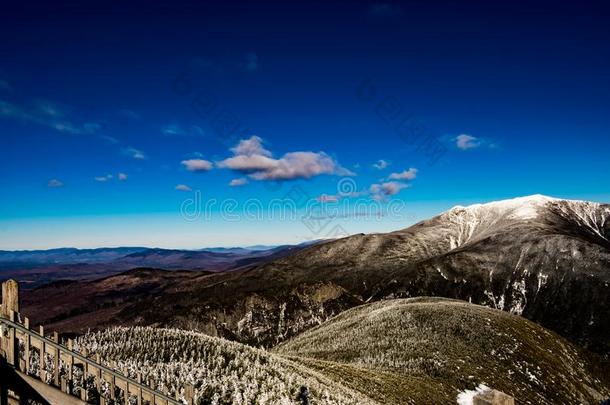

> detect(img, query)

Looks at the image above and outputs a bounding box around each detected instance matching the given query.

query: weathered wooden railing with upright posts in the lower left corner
[0,305,194,405]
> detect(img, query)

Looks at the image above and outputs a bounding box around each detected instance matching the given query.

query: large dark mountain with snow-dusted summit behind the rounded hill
[19,195,610,355]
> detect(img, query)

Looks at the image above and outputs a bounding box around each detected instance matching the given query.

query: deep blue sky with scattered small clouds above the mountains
[0,0,610,250]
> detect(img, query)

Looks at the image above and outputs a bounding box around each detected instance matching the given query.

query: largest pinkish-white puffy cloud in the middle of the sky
[217,136,354,180]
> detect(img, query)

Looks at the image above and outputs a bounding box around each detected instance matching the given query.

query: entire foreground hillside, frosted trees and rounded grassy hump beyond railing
[71,298,610,405]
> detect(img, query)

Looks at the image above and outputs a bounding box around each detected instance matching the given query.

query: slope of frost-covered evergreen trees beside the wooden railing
[75,327,370,405]
